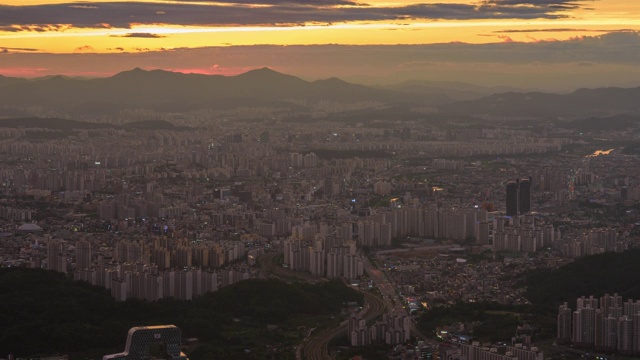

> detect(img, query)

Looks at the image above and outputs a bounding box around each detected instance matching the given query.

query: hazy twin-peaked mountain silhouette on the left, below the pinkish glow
[0,68,416,114]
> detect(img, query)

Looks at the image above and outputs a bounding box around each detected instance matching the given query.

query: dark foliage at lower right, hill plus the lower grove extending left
[418,249,640,340]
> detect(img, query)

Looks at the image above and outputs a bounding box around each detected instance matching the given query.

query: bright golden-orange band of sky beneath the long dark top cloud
[0,0,640,53]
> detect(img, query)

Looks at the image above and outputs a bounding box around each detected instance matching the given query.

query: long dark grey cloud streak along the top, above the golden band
[0,0,592,31]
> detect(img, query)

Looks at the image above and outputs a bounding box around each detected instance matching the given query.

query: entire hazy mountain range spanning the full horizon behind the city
[0,68,640,118]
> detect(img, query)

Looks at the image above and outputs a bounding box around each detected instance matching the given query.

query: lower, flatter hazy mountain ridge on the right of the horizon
[440,87,640,117]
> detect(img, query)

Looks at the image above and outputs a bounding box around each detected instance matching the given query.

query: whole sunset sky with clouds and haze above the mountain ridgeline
[0,0,640,89]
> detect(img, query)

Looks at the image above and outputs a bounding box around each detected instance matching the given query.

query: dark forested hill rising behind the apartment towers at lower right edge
[527,249,640,309]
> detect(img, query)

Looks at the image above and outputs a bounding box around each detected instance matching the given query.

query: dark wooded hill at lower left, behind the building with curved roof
[0,268,362,360]
